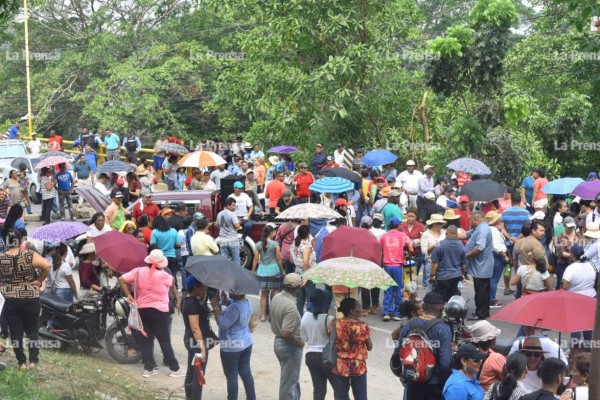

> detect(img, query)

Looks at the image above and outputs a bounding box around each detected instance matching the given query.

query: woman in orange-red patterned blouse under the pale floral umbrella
[331,297,373,400]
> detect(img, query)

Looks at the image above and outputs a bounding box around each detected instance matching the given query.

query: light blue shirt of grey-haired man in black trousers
[466,221,494,279]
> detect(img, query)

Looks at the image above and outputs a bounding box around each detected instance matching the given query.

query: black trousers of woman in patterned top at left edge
[2,298,40,365]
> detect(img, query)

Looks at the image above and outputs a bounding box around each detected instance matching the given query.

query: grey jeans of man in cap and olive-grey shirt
[273,337,302,400]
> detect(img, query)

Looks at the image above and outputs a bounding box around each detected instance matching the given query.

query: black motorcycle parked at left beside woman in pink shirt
[39,286,142,364]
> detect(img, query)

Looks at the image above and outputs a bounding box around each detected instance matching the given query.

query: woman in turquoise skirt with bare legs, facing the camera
[252,225,285,322]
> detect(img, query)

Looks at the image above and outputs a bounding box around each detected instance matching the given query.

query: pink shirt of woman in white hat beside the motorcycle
[122,267,173,312]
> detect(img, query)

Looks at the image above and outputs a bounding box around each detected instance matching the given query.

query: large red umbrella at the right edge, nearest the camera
[490,290,596,332]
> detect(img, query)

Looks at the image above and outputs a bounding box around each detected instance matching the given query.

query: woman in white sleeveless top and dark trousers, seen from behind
[300,289,334,400]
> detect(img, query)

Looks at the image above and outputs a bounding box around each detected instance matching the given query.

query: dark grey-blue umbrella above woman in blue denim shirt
[185,255,260,294]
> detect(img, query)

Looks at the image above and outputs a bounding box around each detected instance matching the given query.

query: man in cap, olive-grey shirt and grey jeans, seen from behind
[270,273,304,400]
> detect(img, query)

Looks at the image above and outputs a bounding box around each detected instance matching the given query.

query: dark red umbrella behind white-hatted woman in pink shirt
[94,231,148,274]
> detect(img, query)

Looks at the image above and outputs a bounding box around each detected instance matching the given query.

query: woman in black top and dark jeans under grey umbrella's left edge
[181,275,211,400]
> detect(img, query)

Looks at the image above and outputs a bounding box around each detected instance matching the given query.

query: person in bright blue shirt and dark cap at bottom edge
[443,343,485,400]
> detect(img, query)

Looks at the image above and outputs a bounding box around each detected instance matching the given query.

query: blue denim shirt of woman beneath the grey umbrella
[217,299,252,353]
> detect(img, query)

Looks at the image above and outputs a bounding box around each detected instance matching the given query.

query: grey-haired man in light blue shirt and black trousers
[459,211,494,321]
